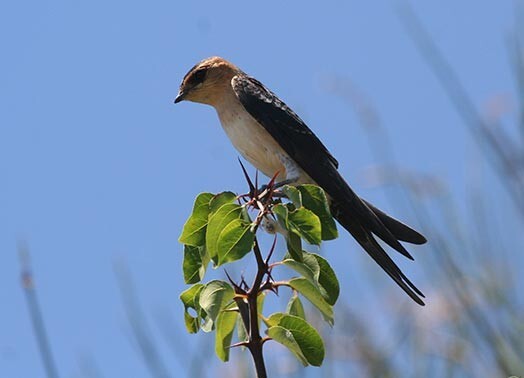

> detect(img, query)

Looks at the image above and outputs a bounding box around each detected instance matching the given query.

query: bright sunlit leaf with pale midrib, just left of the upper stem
[217,219,255,266]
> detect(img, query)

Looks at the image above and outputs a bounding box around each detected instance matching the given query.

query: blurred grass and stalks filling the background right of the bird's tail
[320,6,524,377]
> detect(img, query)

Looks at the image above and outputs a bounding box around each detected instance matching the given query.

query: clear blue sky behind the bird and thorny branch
[0,0,515,377]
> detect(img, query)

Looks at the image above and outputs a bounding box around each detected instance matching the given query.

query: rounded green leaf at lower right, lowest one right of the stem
[266,314,325,366]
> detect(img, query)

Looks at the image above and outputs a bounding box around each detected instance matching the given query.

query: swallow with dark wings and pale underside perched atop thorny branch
[174,56,427,306]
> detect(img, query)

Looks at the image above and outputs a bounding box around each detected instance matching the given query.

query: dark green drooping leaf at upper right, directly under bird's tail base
[297,185,338,240]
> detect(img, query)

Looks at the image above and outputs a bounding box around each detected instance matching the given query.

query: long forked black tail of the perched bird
[331,202,426,306]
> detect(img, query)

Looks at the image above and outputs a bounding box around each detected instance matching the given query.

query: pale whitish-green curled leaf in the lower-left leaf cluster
[199,280,235,332]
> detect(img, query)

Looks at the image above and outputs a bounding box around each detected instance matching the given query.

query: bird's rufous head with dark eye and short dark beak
[175,56,241,105]
